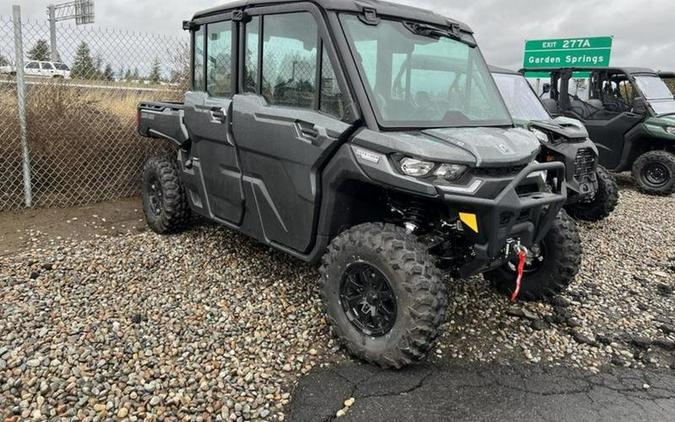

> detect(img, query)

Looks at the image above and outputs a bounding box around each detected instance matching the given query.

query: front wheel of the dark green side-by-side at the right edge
[633,151,675,196]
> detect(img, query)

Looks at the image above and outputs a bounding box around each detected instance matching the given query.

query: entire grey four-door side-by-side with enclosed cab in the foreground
[138,0,580,368]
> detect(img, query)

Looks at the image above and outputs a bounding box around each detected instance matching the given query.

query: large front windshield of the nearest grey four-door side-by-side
[341,15,512,127]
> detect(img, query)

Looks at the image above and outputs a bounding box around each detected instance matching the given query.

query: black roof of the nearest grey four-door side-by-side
[193,0,473,33]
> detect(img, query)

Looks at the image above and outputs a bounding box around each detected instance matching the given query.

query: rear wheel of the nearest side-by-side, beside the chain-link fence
[142,157,190,234]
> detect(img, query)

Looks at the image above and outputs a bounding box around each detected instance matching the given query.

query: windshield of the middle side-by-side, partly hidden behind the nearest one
[492,73,551,121]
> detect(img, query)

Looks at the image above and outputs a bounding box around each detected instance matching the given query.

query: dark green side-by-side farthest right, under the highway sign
[537,68,675,195]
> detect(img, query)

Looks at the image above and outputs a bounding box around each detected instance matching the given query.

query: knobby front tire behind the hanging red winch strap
[484,210,581,300]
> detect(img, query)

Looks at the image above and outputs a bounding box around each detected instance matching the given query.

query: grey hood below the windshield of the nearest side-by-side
[354,127,539,167]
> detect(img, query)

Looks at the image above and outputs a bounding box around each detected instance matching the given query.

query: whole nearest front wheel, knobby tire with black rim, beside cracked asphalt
[320,224,447,368]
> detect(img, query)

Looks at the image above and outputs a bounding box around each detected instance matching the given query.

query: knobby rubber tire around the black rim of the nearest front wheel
[320,223,447,368]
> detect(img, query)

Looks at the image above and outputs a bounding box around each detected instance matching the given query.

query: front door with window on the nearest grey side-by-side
[233,3,352,253]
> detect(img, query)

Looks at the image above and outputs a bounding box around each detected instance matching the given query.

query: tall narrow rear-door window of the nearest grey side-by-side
[206,21,232,97]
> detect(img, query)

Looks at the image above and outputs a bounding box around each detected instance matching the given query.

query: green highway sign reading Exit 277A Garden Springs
[523,37,614,69]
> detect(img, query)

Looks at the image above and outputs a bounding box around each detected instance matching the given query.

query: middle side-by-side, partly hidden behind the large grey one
[490,66,619,221]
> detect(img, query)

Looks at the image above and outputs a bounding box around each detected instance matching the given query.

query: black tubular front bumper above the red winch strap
[438,162,567,277]
